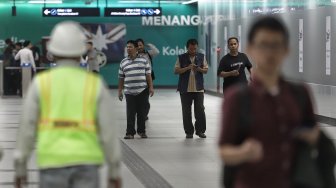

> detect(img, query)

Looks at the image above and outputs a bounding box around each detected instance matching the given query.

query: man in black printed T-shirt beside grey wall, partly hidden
[217,37,252,93]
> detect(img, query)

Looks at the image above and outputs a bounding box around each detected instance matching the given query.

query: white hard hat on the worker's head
[47,21,86,57]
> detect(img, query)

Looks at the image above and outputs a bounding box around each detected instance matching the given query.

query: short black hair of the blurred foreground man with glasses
[248,16,289,45]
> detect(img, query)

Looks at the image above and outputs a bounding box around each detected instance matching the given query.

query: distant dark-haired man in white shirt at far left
[15,41,36,72]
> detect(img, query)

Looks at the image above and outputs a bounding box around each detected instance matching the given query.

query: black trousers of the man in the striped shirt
[125,88,149,135]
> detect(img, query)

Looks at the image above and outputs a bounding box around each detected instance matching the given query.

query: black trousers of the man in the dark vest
[180,92,206,134]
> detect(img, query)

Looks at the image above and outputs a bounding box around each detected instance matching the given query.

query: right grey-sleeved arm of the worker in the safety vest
[97,83,121,184]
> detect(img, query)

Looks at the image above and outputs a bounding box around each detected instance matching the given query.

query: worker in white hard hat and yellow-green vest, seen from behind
[14,21,121,188]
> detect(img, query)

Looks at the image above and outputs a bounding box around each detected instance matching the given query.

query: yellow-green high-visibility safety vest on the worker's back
[36,66,104,168]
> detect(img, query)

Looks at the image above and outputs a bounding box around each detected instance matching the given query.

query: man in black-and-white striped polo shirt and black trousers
[118,40,154,139]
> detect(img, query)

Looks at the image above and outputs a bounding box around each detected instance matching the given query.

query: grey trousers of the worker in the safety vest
[40,165,99,188]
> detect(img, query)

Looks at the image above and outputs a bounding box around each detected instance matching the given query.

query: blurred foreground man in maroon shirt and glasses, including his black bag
[219,17,335,188]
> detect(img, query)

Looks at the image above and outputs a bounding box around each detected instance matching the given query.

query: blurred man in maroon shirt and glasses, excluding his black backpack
[219,17,320,188]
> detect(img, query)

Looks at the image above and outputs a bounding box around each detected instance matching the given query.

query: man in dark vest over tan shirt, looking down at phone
[174,39,208,139]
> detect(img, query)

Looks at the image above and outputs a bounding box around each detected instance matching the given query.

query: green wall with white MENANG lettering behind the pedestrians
[0,3,198,86]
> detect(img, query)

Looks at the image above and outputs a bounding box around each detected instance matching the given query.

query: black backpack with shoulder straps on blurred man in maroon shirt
[222,83,336,188]
